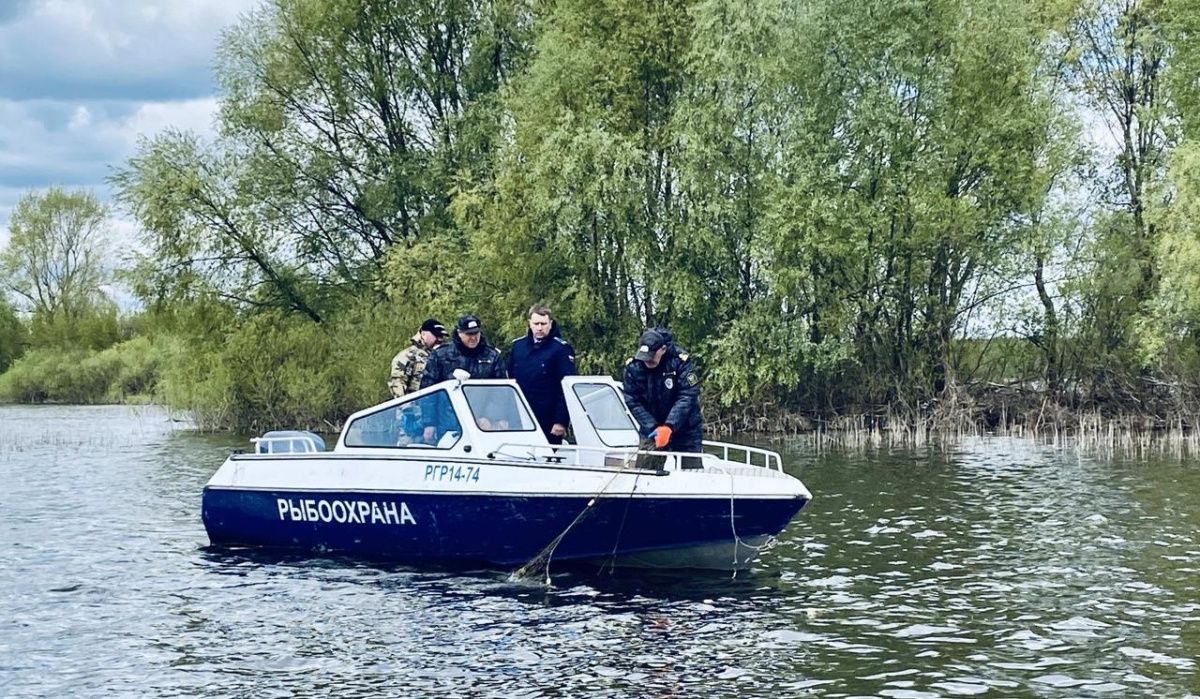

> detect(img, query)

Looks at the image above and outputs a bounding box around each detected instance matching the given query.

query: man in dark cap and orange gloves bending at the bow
[624,328,704,468]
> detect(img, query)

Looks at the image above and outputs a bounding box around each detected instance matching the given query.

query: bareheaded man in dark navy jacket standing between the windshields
[509,304,575,444]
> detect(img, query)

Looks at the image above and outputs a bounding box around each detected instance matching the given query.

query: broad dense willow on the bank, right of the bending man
[772,0,1052,405]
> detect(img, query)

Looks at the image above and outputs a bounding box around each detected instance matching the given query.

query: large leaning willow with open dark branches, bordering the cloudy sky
[114,0,528,426]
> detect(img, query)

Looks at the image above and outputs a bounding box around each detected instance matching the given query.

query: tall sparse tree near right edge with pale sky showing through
[1073,0,1175,406]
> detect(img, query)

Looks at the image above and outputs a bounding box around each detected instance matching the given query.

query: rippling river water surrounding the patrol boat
[0,406,1200,698]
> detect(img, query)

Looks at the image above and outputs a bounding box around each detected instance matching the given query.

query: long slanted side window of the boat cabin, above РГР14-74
[346,390,462,449]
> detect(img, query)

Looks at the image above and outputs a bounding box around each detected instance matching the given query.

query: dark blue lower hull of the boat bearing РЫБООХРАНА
[203,486,808,566]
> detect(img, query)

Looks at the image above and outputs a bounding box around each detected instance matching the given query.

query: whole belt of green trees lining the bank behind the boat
[0,0,1200,429]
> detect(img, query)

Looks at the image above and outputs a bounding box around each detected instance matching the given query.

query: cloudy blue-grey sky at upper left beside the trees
[0,0,262,247]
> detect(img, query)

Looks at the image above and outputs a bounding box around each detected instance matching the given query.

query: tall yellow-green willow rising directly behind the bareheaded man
[460,0,690,370]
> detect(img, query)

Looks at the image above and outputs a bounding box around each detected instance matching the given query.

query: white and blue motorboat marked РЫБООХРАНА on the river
[202,376,811,570]
